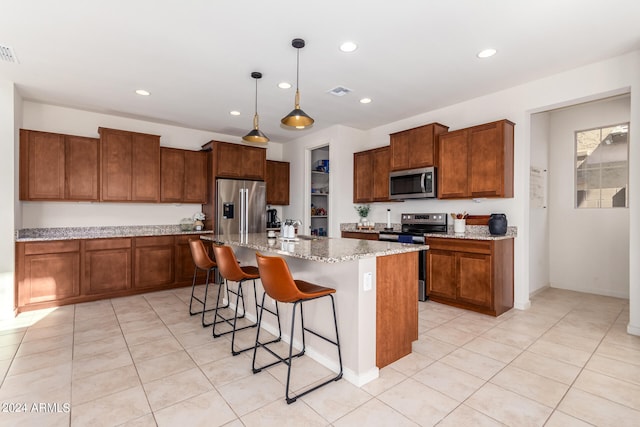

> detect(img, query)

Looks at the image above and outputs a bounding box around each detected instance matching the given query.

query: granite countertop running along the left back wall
[16,224,213,242]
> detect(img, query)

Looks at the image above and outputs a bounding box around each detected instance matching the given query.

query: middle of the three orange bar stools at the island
[213,244,282,356]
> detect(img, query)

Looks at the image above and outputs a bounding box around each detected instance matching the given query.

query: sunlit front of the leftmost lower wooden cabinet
[16,241,80,307]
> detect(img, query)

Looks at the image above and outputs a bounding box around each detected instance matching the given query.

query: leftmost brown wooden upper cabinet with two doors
[20,129,99,201]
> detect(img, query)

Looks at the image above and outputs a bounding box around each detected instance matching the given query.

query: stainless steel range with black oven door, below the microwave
[379,213,448,301]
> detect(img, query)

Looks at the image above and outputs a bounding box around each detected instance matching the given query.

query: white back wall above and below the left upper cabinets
[21,102,282,228]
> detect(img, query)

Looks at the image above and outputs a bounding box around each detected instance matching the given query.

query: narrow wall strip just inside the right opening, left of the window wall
[529,113,550,294]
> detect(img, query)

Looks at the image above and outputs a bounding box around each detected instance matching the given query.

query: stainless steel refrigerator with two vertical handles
[216,179,267,235]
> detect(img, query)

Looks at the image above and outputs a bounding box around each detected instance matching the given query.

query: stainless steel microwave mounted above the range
[389,166,437,200]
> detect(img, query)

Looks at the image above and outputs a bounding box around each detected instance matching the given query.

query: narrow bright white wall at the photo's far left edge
[0,80,20,319]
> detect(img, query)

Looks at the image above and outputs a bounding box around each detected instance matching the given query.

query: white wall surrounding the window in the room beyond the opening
[549,97,635,298]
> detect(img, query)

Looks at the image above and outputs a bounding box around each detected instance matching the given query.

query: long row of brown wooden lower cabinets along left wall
[14,234,206,312]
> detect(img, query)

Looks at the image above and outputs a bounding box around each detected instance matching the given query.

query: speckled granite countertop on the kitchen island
[201,233,429,264]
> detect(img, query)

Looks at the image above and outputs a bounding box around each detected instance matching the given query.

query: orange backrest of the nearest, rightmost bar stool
[256,252,304,302]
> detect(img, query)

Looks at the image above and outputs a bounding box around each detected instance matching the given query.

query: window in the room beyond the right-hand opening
[575,123,629,208]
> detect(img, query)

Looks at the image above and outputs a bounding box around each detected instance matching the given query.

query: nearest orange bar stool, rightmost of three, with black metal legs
[252,253,342,404]
